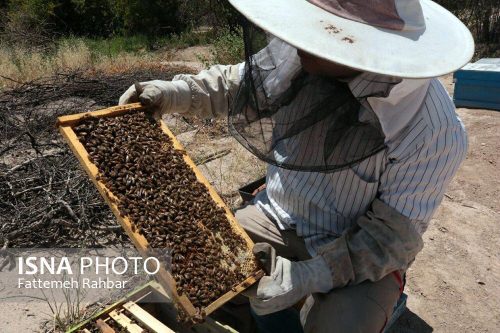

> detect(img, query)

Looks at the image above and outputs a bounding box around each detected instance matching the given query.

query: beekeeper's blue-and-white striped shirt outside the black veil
[256,73,467,256]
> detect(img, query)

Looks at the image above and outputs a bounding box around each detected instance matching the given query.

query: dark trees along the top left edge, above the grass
[0,0,239,37]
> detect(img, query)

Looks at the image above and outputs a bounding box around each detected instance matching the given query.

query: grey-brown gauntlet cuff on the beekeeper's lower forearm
[318,199,423,289]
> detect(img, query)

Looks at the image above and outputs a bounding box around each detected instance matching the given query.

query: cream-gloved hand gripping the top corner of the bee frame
[118,80,191,119]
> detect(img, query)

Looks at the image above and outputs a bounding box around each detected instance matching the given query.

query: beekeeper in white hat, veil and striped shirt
[120,0,474,332]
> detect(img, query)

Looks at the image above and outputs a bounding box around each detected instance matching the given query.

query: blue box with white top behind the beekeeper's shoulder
[453,58,500,110]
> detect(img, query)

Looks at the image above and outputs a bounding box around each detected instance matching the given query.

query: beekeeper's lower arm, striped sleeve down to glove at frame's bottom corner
[250,104,467,315]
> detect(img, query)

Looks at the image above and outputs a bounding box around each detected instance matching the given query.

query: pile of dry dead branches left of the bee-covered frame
[0,68,197,247]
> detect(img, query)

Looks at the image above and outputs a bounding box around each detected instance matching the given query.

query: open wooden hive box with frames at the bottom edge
[66,281,237,333]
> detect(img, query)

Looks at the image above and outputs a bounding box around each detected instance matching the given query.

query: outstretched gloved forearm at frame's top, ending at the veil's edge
[119,64,243,118]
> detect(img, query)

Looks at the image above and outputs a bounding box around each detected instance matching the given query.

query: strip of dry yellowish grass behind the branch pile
[0,27,234,90]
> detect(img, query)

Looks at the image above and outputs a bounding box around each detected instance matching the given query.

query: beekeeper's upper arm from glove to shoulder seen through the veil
[119,38,300,118]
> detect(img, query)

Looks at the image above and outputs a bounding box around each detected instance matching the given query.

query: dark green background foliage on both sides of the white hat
[0,0,500,62]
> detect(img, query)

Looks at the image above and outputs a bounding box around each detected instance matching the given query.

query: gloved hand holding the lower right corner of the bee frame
[247,243,333,316]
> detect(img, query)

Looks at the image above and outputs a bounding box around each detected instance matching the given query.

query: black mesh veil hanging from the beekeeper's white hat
[228,21,384,172]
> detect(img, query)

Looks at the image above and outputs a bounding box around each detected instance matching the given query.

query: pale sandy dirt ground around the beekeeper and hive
[0,68,500,333]
